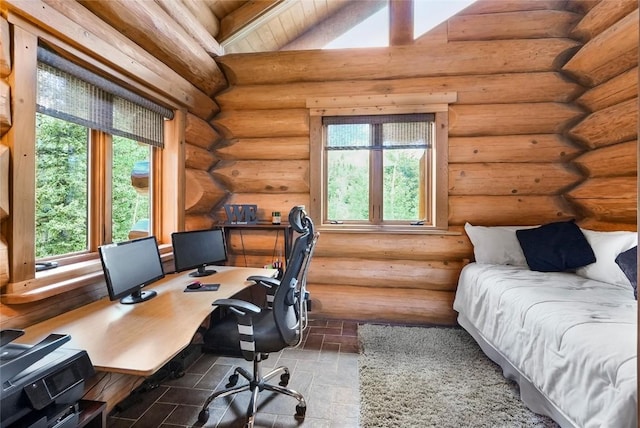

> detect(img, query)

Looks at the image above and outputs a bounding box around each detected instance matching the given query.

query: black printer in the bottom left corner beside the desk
[0,329,95,428]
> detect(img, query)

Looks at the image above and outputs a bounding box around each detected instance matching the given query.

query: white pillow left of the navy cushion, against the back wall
[464,223,535,266]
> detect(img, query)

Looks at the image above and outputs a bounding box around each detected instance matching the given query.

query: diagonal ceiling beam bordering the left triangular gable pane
[280,0,384,51]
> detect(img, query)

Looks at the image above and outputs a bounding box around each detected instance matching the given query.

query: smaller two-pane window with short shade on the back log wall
[323,114,436,225]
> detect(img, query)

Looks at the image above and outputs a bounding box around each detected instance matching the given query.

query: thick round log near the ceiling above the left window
[79,0,227,96]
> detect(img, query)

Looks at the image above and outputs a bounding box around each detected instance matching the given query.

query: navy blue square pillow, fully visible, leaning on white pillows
[516,220,596,272]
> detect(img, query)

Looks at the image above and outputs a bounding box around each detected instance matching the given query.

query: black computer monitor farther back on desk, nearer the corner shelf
[171,228,227,277]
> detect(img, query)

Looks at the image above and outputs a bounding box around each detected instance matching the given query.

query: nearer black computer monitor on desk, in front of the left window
[98,236,164,304]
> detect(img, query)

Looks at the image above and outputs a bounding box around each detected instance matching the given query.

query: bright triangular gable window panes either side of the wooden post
[323,0,475,49]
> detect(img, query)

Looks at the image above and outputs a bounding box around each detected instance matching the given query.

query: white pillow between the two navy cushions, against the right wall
[576,229,638,287]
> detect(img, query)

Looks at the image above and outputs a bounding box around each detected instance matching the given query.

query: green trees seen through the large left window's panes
[35,114,151,258]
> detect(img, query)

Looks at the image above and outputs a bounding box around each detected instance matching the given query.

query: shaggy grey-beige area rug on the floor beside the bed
[358,324,558,428]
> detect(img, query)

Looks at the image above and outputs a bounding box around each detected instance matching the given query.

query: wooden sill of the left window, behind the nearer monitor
[0,245,173,305]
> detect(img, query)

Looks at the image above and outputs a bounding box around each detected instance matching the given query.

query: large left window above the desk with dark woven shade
[35,48,172,259]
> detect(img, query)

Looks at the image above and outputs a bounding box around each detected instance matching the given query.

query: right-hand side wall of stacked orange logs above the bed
[563,0,639,230]
